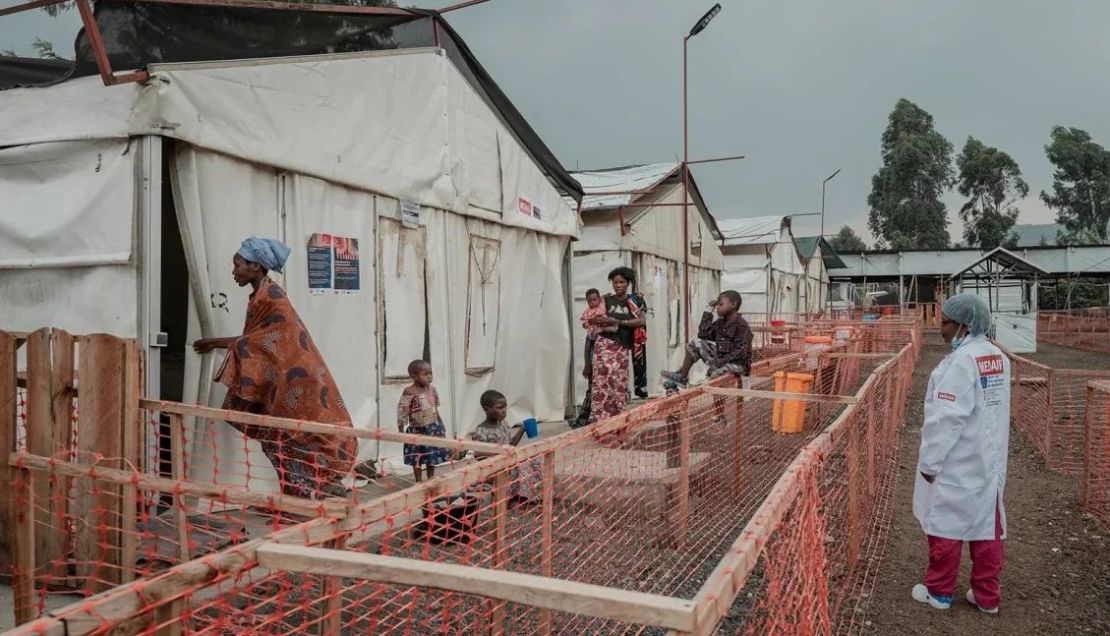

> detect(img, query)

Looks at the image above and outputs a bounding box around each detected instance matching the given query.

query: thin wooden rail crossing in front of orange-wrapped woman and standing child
[139,400,508,453]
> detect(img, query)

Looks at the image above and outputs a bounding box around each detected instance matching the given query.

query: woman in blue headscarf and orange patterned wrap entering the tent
[193,236,357,498]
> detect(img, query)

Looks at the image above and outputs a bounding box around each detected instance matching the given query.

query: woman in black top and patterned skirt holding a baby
[589,267,647,424]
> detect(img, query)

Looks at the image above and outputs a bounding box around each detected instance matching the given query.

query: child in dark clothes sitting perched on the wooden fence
[662,290,751,385]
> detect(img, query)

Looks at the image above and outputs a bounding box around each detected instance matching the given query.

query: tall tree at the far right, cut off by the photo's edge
[1041,125,1110,244]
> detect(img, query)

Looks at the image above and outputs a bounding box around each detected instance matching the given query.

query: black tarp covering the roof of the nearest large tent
[0,0,582,200]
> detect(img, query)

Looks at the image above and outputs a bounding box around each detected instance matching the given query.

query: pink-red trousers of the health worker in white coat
[925,507,1006,609]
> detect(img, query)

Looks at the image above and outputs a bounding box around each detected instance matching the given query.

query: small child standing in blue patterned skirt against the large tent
[397,360,451,482]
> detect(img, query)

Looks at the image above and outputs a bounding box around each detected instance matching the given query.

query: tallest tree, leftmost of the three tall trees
[867,99,953,250]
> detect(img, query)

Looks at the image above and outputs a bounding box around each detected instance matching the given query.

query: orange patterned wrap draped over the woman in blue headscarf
[216,277,357,473]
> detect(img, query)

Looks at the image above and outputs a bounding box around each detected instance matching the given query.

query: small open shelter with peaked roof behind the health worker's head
[949,248,1048,353]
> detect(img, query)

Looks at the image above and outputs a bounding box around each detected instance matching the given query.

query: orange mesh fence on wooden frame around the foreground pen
[2,320,920,634]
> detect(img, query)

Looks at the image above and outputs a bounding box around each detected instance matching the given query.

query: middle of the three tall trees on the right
[956,137,1029,250]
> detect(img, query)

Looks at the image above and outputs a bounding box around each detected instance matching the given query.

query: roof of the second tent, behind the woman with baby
[571,161,722,240]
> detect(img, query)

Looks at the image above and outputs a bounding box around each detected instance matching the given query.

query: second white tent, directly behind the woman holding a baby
[572,163,723,395]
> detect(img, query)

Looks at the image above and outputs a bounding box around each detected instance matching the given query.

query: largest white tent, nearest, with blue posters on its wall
[0,49,578,470]
